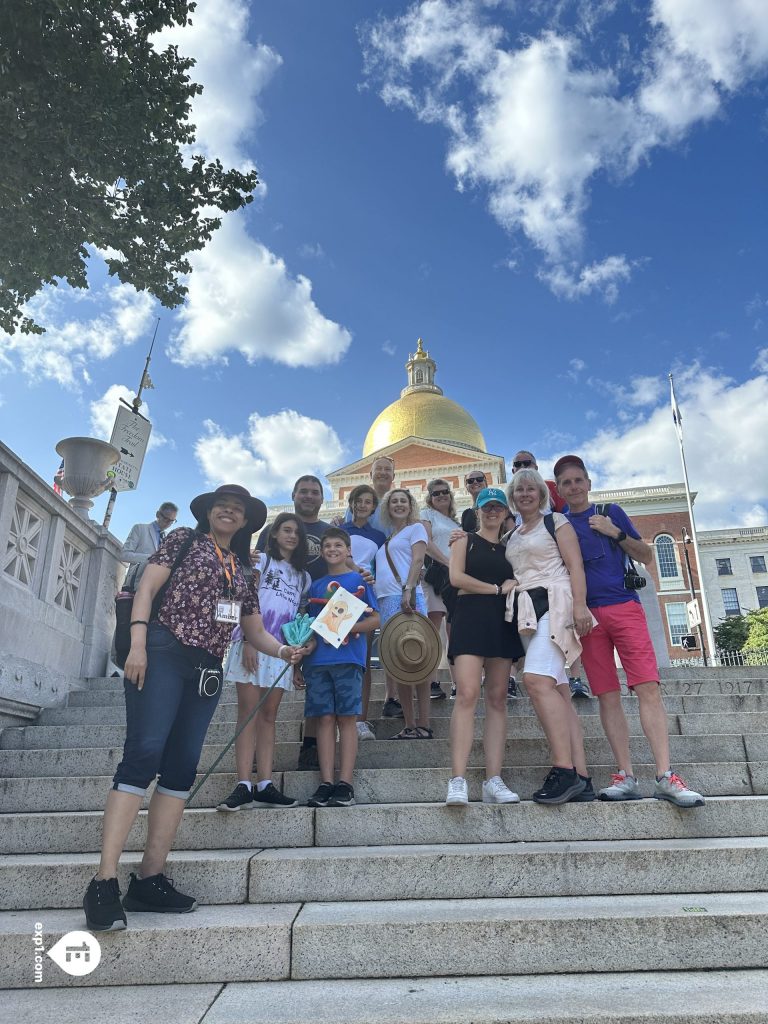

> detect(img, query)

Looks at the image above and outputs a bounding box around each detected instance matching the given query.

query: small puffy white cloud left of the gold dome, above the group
[195,409,345,498]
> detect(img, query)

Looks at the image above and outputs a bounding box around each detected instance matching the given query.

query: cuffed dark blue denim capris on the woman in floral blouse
[113,623,221,800]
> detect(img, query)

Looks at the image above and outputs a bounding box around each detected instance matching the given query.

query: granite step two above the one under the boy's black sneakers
[0,733,753,778]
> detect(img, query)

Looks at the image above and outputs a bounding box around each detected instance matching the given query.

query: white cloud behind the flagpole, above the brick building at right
[557,365,768,528]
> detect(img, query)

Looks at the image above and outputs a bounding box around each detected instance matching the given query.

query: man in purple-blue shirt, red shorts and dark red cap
[554,455,703,807]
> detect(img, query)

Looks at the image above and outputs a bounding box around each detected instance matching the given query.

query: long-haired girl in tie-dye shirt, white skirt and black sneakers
[218,512,311,811]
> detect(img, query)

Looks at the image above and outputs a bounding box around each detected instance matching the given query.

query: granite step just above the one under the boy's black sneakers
[0,761,753,814]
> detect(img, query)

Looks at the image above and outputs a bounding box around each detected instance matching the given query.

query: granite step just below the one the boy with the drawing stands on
[0,838,768,911]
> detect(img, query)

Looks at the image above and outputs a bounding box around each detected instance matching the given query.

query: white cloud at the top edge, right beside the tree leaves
[155,0,283,170]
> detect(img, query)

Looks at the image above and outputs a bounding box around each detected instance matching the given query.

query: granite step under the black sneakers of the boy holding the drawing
[0,797,768,854]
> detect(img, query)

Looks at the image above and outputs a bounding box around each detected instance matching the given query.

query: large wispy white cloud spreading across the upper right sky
[362,0,768,302]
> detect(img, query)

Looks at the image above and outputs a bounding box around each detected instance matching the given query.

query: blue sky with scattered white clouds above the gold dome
[0,0,768,537]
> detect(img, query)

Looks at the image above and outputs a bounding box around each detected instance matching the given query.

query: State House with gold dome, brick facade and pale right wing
[269,338,768,658]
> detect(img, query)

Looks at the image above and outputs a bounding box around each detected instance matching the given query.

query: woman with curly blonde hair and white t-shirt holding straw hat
[376,487,432,739]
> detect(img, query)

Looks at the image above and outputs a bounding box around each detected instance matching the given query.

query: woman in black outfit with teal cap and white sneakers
[445,487,523,806]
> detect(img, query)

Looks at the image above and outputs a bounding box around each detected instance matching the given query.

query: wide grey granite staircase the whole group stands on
[0,669,768,1024]
